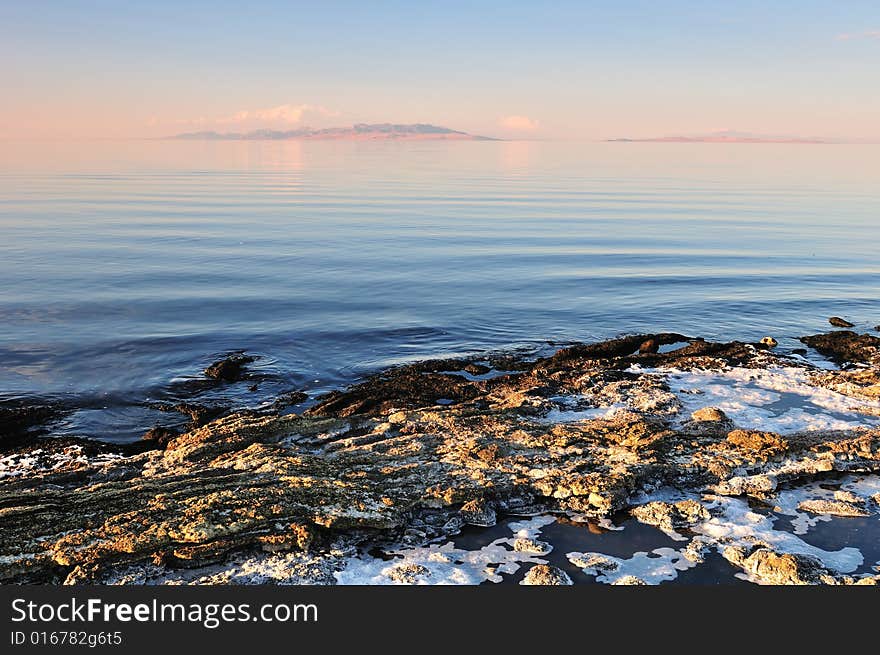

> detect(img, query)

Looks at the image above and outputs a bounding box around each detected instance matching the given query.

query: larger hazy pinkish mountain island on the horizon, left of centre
[169,123,497,141]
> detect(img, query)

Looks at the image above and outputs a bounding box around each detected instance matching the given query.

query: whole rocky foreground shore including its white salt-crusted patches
[0,330,880,584]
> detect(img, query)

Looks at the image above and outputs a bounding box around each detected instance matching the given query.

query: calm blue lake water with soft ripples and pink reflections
[0,141,880,440]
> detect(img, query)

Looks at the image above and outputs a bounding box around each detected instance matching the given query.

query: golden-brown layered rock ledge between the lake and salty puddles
[0,332,880,583]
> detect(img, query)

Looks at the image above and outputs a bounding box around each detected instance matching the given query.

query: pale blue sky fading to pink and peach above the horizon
[0,0,880,141]
